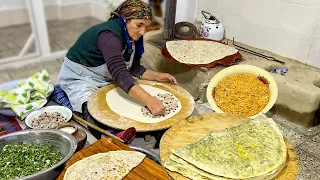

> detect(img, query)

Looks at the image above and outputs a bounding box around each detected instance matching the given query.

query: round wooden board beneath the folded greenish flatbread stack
[160,113,298,180]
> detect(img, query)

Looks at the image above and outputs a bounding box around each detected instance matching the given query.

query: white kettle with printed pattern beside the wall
[200,11,224,41]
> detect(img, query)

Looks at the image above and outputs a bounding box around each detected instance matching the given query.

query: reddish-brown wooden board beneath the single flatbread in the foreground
[57,137,169,180]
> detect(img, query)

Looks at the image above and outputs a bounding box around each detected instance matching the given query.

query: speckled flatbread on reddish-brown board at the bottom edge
[63,151,145,180]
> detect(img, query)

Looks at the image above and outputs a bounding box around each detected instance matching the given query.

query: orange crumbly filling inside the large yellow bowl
[213,74,269,117]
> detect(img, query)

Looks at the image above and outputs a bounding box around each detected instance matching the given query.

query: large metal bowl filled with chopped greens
[0,129,77,180]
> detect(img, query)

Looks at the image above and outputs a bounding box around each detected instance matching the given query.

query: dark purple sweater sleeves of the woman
[98,31,146,93]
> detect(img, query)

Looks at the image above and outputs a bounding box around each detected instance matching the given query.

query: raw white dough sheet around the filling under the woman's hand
[106,85,181,123]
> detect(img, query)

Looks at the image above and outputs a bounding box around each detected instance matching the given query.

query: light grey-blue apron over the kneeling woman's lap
[59,45,135,113]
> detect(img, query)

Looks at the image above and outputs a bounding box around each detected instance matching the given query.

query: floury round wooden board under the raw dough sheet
[88,80,194,132]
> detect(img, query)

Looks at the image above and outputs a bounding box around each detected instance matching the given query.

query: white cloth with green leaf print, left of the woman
[0,70,53,119]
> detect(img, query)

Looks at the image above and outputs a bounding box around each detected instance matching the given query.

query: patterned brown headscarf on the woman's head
[111,0,152,20]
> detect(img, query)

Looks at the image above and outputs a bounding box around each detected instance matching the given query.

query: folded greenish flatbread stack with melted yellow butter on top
[164,117,287,180]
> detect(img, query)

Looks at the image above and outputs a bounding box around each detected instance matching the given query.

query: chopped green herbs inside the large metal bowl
[0,144,62,180]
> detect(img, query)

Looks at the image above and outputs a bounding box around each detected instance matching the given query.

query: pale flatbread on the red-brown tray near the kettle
[166,40,238,64]
